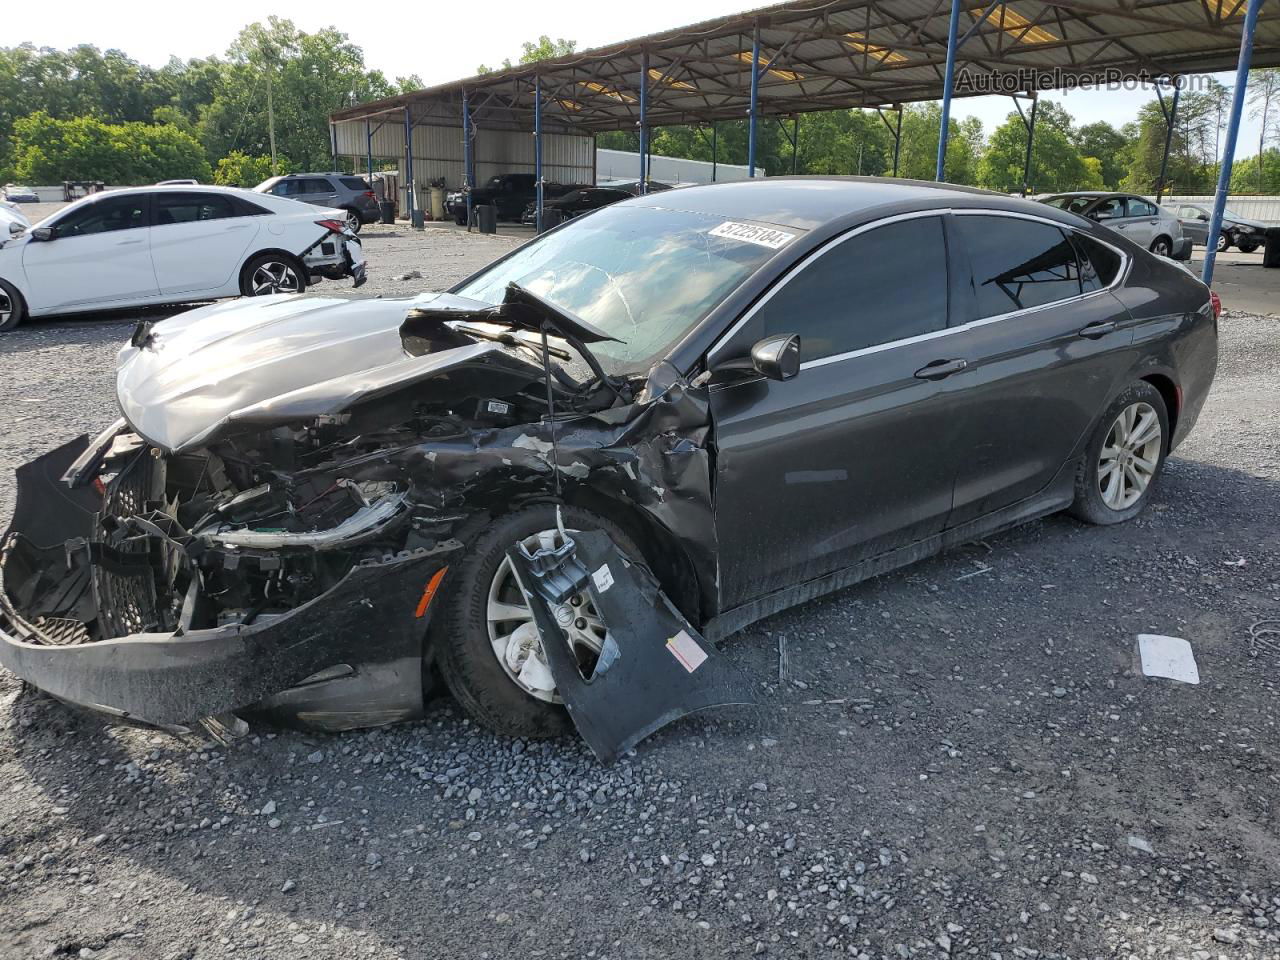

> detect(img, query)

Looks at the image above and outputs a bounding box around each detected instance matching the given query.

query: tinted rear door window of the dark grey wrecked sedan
[955,216,1080,317]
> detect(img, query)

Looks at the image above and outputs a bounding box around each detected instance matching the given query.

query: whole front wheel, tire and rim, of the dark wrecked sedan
[435,504,640,737]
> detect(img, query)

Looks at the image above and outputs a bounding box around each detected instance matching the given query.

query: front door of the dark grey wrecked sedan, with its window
[710,214,957,608]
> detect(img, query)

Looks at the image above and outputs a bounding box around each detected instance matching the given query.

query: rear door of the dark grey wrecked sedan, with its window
[946,211,1133,526]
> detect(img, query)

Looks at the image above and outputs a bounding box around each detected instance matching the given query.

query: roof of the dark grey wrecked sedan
[620,177,1075,230]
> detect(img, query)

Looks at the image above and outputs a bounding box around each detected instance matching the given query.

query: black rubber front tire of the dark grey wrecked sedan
[431,504,640,740]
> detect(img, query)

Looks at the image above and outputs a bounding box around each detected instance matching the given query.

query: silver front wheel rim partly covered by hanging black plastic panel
[485,530,608,703]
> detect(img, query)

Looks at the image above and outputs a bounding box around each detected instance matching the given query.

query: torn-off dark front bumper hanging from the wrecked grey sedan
[0,440,450,730]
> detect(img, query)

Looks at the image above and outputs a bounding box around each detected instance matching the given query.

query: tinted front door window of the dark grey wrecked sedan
[758,216,947,360]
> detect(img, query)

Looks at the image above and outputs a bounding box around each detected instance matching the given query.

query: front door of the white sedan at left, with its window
[22,193,157,314]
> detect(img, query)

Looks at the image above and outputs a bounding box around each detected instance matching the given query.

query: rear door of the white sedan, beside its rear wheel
[151,191,261,296]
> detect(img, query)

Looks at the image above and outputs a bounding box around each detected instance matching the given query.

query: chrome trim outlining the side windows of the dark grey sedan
[707,207,1133,370]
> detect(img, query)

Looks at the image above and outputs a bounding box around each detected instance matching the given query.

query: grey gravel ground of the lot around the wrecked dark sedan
[0,227,1280,960]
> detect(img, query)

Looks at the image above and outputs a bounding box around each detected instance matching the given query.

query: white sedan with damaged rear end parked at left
[0,187,365,330]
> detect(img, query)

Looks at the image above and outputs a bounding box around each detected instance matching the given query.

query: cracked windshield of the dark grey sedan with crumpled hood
[456,206,796,374]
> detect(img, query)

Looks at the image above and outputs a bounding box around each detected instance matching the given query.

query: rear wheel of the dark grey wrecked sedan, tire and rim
[1069,380,1170,526]
